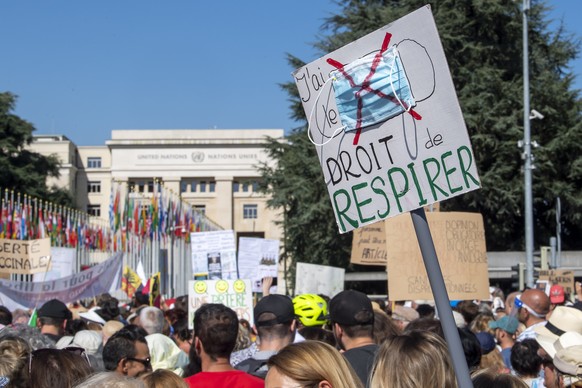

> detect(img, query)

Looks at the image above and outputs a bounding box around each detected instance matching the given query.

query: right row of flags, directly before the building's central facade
[109,180,222,251]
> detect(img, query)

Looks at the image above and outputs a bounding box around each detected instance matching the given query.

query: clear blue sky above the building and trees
[0,0,582,145]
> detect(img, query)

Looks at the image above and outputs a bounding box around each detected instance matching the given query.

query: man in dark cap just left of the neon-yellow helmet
[235,294,297,379]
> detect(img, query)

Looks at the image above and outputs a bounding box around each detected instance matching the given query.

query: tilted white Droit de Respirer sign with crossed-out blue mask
[293,6,480,233]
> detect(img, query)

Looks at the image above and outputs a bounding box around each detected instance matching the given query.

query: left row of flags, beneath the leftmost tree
[0,189,111,251]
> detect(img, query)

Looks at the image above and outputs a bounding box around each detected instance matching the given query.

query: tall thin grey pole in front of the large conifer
[522,0,534,287]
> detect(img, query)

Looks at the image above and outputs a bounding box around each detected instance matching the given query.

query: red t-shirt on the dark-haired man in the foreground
[184,370,265,388]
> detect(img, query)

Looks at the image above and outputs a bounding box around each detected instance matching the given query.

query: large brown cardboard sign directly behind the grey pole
[385,212,489,300]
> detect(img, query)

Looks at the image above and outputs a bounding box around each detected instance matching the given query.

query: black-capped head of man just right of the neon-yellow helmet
[329,290,374,349]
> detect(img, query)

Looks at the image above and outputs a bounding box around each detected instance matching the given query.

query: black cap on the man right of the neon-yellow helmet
[329,290,374,326]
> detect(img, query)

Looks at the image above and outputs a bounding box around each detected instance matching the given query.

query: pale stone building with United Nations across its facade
[30,129,284,240]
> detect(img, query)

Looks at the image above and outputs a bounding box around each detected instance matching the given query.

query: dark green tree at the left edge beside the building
[0,92,72,206]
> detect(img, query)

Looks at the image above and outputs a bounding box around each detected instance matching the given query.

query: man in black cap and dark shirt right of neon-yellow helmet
[329,290,378,386]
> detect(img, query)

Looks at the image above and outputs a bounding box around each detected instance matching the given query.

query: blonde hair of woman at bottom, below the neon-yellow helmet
[265,341,362,388]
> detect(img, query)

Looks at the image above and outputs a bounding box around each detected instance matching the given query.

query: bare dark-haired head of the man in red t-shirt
[194,303,238,365]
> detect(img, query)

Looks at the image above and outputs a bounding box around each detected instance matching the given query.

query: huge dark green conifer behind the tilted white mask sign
[263,0,582,274]
